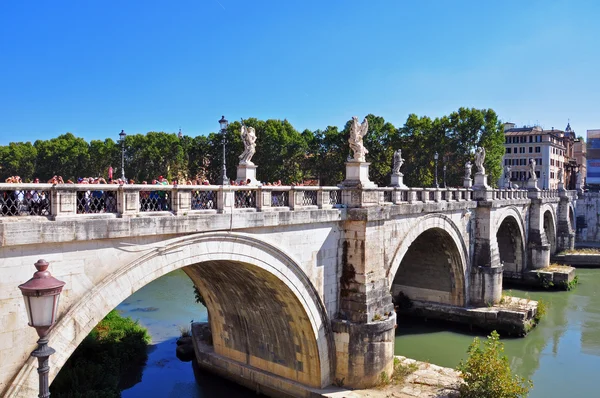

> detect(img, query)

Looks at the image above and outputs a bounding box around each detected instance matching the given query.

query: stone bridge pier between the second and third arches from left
[469,204,503,306]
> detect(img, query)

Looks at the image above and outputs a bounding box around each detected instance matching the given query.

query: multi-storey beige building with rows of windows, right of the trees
[500,123,573,189]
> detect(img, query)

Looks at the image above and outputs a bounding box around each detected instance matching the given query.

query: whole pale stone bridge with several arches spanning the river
[0,184,575,397]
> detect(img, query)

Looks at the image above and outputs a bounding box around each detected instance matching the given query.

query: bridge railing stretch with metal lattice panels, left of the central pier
[0,184,342,217]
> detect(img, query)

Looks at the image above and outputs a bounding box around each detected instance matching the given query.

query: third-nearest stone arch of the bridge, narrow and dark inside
[495,206,527,277]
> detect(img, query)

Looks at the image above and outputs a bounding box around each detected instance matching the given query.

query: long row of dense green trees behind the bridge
[0,108,504,186]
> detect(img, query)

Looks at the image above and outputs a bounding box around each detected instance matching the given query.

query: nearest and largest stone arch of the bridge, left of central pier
[7,232,335,397]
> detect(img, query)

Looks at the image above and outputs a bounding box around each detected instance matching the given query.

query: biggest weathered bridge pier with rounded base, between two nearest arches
[332,218,396,388]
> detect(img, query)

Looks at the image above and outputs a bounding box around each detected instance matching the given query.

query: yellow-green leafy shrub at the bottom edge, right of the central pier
[457,331,533,398]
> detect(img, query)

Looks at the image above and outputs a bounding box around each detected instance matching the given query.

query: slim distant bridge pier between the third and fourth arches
[527,191,550,269]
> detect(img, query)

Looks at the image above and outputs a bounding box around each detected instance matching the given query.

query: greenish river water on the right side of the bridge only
[396,269,600,398]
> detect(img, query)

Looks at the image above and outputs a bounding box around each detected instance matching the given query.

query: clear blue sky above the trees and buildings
[0,0,600,145]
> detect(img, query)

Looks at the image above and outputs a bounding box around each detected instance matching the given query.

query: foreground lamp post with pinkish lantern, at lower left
[19,260,65,398]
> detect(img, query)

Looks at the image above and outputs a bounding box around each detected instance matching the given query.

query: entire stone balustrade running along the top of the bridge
[0,184,576,219]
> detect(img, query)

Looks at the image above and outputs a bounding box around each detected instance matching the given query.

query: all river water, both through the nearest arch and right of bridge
[117,269,600,398]
